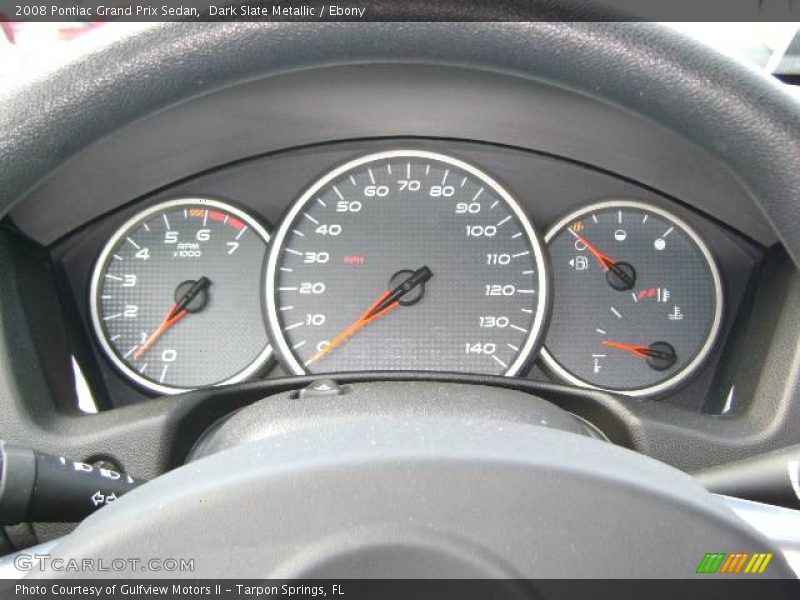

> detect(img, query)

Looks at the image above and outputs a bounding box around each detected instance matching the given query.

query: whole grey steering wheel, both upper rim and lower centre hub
[0,22,800,577]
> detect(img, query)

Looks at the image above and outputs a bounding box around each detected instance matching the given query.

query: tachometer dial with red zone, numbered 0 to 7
[91,199,272,393]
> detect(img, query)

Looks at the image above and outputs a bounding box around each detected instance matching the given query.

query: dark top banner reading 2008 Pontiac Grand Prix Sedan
[0,0,800,22]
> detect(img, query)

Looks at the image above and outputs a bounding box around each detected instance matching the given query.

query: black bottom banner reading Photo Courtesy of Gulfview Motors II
[0,578,800,600]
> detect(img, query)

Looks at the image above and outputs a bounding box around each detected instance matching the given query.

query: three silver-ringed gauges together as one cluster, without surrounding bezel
[86,147,726,397]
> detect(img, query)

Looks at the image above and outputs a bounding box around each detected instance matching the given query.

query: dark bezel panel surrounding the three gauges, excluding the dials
[42,139,759,410]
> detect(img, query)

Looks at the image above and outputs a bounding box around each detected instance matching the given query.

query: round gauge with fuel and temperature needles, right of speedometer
[542,201,722,396]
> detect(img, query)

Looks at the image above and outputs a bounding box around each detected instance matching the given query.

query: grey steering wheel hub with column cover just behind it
[32,382,787,578]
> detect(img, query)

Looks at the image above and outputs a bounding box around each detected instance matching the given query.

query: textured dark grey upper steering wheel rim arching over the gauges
[0,22,800,264]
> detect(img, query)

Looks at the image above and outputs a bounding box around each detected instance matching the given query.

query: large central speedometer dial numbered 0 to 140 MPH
[266,151,548,375]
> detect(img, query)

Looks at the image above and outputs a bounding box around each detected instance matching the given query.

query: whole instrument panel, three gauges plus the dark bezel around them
[10,138,766,414]
